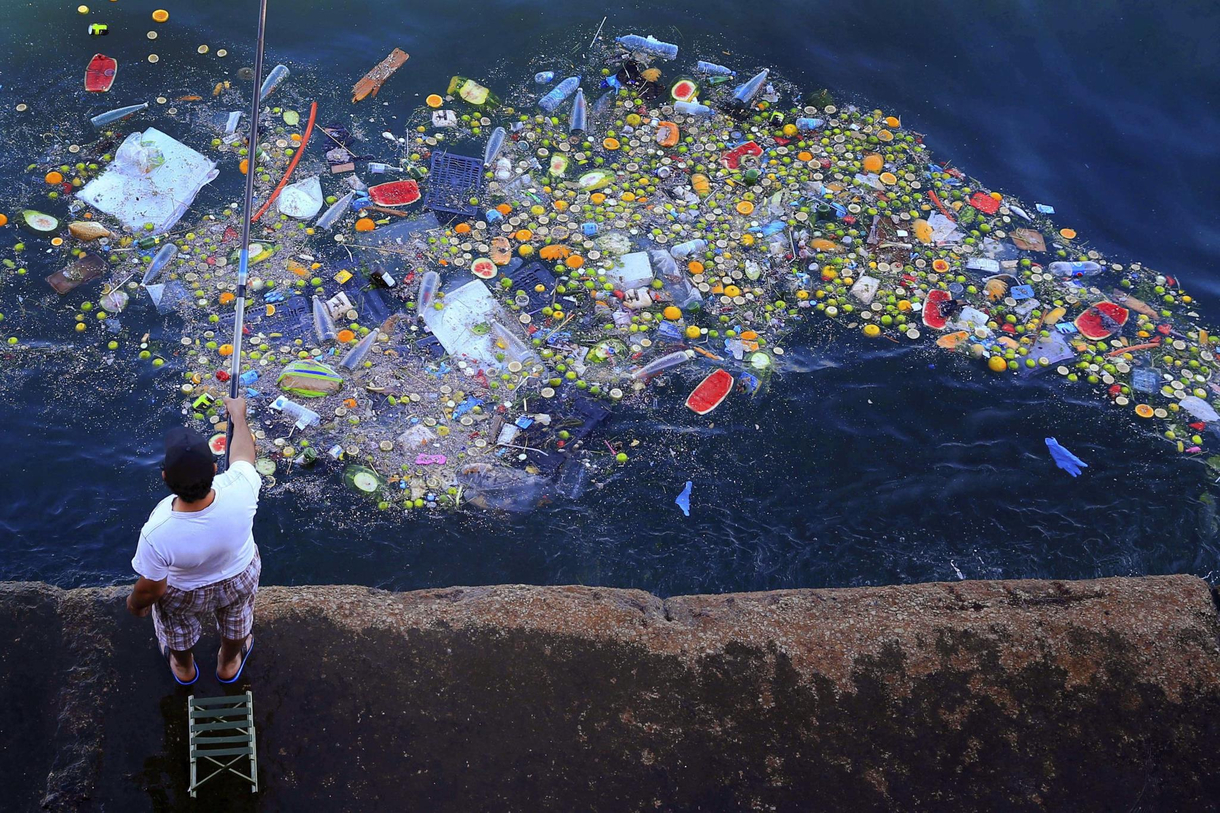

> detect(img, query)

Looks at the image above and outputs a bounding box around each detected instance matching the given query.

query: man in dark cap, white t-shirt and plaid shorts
[127,398,262,686]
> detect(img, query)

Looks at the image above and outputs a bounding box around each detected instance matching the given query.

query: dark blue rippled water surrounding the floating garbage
[0,0,1220,593]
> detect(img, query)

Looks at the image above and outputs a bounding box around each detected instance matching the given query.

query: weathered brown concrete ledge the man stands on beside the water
[0,576,1220,812]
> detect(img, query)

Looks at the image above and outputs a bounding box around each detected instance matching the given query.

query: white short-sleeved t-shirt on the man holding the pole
[132,460,262,590]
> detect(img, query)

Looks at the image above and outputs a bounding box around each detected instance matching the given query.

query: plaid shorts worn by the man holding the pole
[153,548,262,652]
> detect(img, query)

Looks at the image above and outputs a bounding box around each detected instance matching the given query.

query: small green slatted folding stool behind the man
[187,692,259,797]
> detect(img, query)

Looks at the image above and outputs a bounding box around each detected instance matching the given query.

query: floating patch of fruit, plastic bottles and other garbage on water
[2,33,1220,513]
